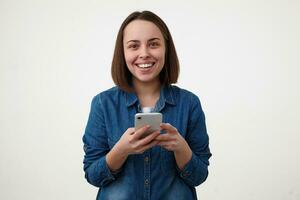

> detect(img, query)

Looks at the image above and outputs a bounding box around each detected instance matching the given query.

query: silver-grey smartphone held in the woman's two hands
[134,113,162,138]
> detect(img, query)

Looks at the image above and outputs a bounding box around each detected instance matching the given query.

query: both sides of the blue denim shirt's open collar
[125,86,176,108]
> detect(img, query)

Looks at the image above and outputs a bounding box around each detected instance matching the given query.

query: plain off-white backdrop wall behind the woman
[0,0,300,200]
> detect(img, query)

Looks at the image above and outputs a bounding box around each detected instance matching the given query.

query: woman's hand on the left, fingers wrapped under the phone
[116,126,160,155]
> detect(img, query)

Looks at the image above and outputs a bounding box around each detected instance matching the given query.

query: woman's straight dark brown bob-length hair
[111,11,179,92]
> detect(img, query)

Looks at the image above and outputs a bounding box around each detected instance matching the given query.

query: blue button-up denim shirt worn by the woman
[83,86,211,200]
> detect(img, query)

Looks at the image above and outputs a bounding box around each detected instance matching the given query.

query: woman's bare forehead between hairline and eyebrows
[124,20,163,42]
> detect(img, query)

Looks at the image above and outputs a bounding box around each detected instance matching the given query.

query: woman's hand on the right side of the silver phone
[155,123,187,152]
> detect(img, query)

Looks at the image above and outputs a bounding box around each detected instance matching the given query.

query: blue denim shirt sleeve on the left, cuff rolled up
[82,95,119,187]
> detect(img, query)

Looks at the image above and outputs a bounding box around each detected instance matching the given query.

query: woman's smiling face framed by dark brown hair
[123,20,166,84]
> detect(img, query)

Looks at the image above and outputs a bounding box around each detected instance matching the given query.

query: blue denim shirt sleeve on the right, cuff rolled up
[177,95,212,187]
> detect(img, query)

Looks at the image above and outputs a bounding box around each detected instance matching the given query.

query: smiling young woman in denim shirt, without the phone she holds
[83,11,211,200]
